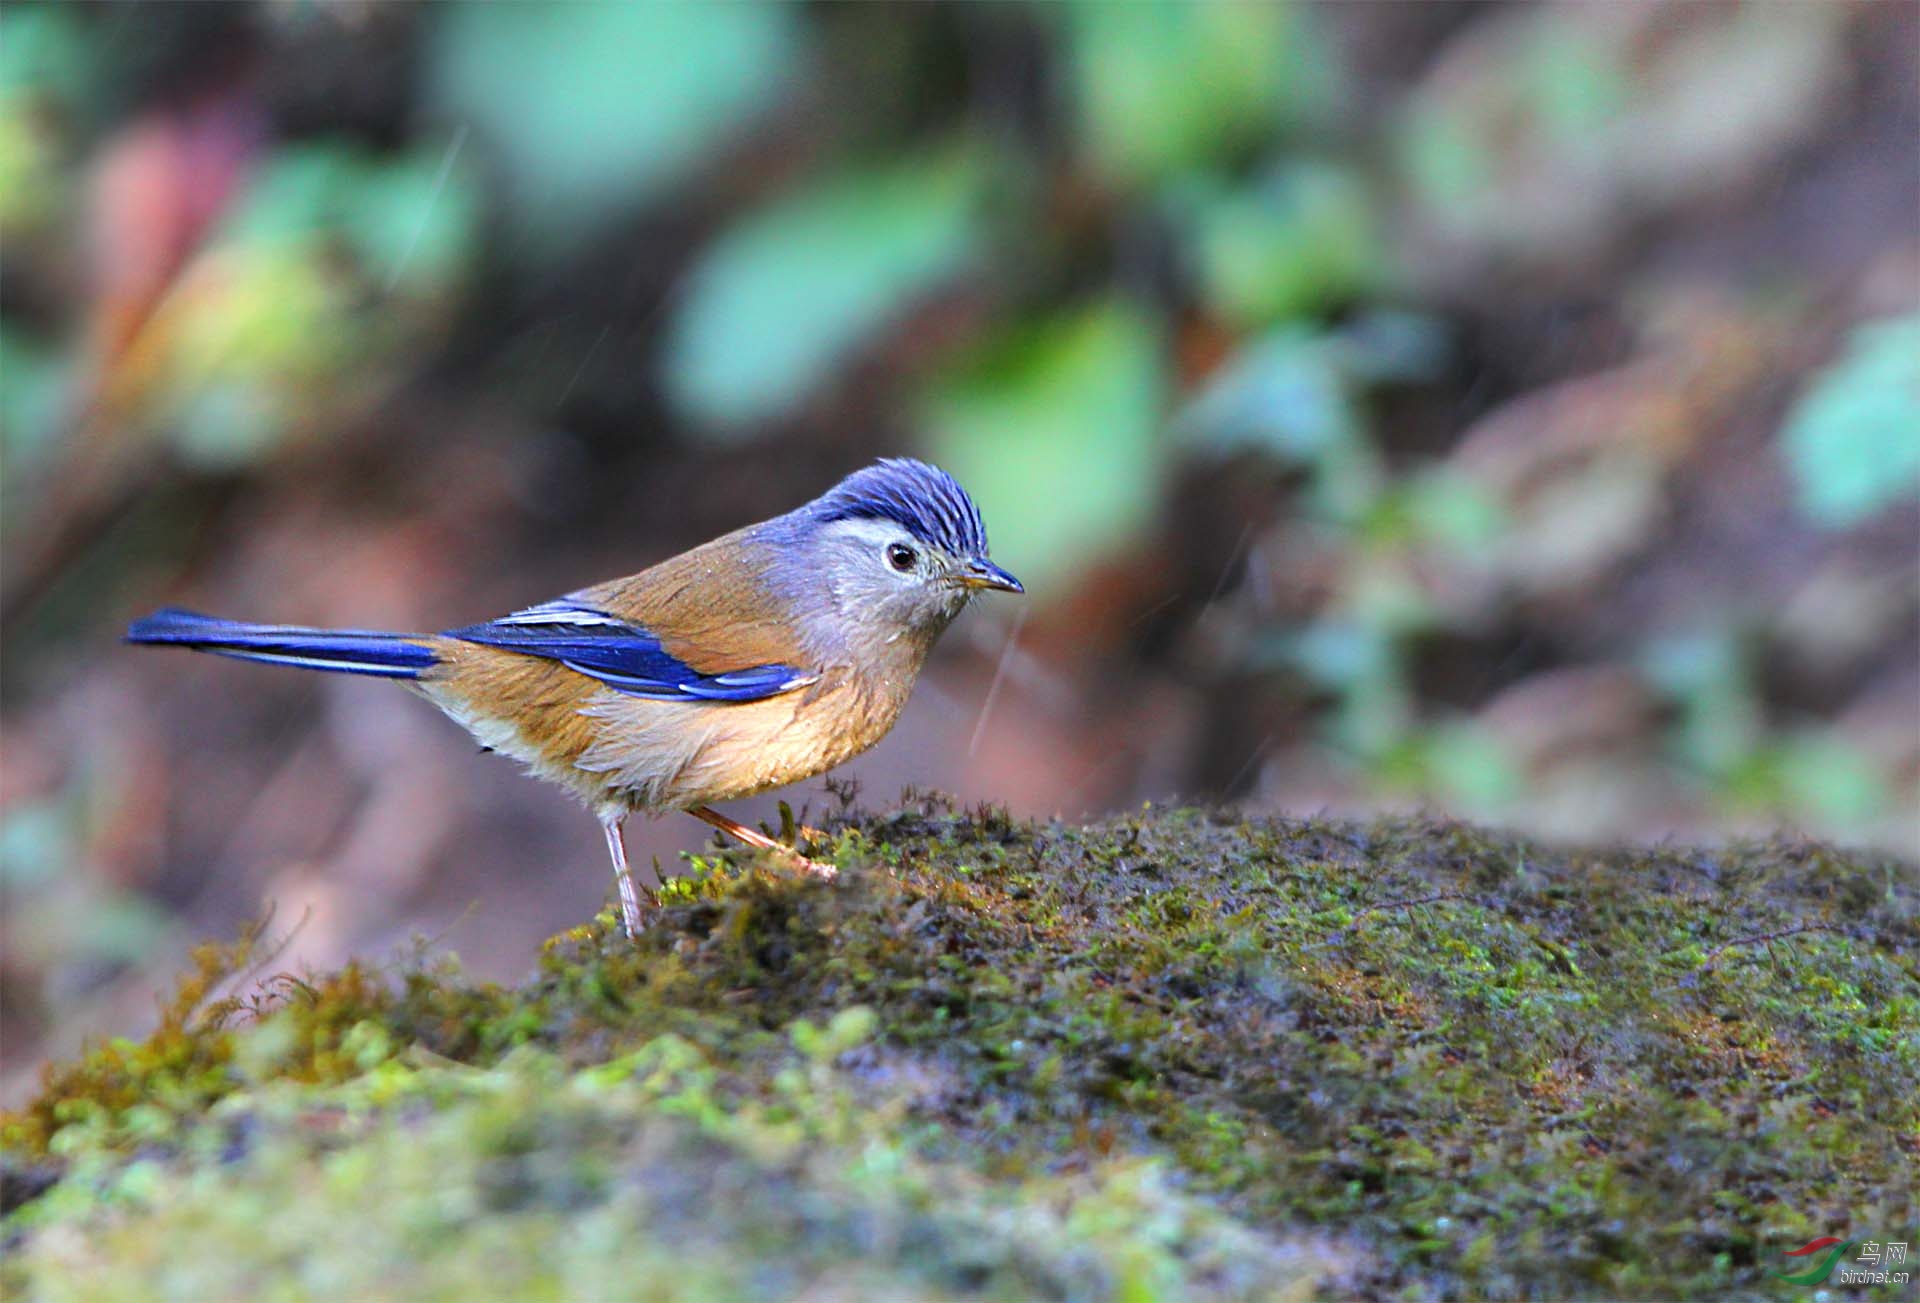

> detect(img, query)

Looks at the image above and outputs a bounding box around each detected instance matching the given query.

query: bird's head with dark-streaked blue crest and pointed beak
[789,457,1025,656]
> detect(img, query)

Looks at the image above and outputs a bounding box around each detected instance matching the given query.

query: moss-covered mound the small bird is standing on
[0,802,1920,1299]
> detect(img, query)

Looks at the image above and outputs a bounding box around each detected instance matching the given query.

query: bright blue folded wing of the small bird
[445,599,820,702]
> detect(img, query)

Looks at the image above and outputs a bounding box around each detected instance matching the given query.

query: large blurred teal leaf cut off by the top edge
[428,0,801,244]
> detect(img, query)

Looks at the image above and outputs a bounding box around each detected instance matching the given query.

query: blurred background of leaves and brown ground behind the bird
[0,0,1920,1092]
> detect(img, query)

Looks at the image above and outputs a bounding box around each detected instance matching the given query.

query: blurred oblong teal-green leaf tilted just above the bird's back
[666,147,983,438]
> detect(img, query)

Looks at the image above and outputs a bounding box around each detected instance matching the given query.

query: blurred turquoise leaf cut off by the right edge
[1780,315,1920,530]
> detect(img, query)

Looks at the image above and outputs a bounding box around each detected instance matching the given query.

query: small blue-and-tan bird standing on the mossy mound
[127,457,1025,936]
